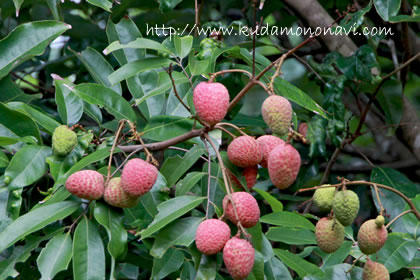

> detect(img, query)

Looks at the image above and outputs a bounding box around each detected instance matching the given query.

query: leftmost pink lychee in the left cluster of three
[66,170,104,200]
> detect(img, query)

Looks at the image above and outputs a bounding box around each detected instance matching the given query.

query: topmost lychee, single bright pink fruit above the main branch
[193,82,229,125]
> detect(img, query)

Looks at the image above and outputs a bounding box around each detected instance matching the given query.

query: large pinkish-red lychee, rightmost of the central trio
[268,144,300,190]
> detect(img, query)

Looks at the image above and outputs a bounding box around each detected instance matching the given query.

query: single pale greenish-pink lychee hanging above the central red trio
[261,95,293,135]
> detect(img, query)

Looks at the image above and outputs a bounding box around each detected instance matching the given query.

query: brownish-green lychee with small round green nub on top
[357,216,388,255]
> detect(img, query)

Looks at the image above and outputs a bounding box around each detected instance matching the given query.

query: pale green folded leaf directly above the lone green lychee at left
[54,79,84,125]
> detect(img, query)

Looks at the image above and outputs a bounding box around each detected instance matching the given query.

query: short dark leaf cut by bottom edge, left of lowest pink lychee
[151,248,184,279]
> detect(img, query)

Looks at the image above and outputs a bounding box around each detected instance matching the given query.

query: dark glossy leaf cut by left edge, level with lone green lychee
[0,103,42,143]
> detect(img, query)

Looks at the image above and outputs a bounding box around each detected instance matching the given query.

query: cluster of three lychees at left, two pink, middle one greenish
[65,158,158,208]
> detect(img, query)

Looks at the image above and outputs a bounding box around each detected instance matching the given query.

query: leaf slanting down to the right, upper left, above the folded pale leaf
[77,47,122,95]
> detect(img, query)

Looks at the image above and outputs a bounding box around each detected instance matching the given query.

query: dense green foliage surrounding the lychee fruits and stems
[0,0,420,279]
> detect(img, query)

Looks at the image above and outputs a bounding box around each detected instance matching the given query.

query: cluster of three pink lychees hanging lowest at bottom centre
[195,192,260,279]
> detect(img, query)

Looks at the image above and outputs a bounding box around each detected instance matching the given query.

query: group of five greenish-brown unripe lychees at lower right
[313,187,389,280]
